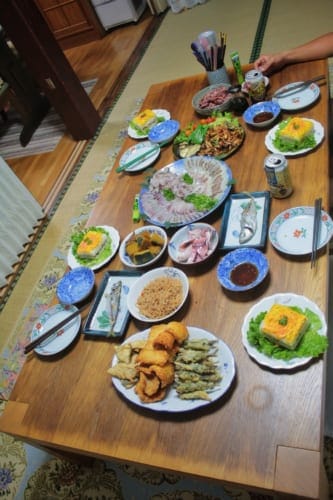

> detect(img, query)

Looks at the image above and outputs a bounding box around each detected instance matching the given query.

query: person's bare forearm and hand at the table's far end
[254,32,333,73]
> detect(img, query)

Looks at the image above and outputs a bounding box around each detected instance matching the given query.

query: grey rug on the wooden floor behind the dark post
[0,79,97,159]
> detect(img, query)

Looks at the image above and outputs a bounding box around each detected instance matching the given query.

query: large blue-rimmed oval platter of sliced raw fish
[139,156,232,227]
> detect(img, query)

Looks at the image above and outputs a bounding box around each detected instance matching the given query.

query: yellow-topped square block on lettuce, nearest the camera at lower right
[261,304,308,349]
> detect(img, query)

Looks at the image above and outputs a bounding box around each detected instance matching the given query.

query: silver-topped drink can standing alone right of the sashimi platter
[264,153,293,198]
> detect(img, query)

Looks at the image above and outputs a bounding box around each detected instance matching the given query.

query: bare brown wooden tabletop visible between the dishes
[0,60,329,498]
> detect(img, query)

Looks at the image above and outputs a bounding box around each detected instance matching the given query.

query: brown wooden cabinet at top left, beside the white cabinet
[34,0,105,49]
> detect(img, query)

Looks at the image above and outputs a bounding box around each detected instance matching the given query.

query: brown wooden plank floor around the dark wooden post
[6,9,160,212]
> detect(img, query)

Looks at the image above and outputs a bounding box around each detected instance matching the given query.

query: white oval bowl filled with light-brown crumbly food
[127,267,189,323]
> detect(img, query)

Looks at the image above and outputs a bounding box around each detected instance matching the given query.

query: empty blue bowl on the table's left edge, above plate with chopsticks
[57,266,95,305]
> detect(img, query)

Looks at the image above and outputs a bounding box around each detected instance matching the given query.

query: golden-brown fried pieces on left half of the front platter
[108,321,188,403]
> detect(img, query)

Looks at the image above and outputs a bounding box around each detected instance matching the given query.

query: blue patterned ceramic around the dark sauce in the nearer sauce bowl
[217,248,269,292]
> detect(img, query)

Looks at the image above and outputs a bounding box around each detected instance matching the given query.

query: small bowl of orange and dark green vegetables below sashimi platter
[119,226,168,269]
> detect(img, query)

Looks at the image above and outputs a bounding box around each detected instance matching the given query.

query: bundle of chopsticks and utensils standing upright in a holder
[191,31,227,71]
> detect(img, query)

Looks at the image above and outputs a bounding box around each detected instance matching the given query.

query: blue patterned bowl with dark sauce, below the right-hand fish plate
[217,248,269,292]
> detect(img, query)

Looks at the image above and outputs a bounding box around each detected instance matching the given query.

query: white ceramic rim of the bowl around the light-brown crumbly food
[127,267,189,323]
